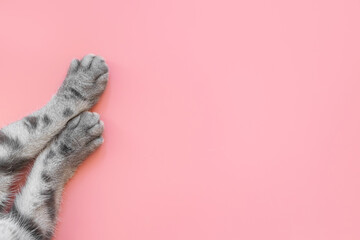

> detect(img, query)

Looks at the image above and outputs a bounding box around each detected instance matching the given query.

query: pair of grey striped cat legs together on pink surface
[0,54,108,240]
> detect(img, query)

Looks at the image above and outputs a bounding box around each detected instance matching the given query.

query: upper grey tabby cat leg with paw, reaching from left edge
[0,55,108,210]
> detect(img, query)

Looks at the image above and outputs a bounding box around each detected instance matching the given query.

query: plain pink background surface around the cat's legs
[0,0,360,240]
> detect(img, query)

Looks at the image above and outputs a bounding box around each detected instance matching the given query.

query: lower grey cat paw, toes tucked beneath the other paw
[56,112,104,168]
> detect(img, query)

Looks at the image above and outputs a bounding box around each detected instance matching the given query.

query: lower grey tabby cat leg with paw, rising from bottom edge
[7,112,104,239]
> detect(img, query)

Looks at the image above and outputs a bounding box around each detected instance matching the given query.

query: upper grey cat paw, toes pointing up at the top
[58,54,109,111]
